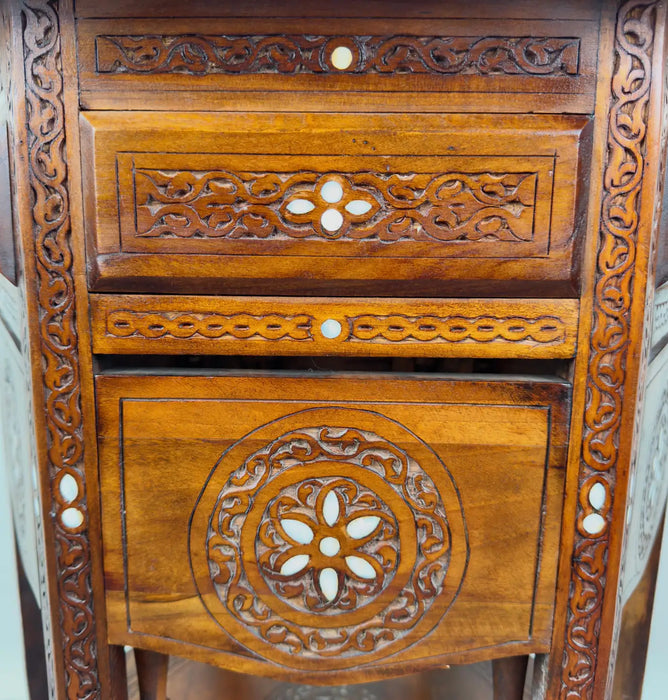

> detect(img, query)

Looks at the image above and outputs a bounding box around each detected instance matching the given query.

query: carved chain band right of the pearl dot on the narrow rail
[350,315,566,343]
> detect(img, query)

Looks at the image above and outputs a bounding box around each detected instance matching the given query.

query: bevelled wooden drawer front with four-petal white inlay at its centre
[82,113,588,295]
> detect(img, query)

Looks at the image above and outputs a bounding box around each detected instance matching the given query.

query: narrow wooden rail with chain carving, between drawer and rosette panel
[91,294,579,359]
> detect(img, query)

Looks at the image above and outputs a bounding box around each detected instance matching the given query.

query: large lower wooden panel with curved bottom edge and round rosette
[97,374,569,682]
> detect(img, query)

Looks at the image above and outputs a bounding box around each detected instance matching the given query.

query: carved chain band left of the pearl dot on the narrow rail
[107,311,313,340]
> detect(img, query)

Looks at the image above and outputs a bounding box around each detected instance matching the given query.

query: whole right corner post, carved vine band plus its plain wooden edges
[553,0,663,698]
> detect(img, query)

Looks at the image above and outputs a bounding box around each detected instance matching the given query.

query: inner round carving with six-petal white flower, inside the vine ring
[255,476,400,612]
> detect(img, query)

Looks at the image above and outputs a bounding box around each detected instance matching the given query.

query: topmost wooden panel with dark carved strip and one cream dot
[77,1,598,113]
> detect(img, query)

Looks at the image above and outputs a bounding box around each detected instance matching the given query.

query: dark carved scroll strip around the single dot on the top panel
[95,34,580,77]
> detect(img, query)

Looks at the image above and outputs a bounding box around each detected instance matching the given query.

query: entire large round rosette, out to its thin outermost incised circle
[190,408,468,670]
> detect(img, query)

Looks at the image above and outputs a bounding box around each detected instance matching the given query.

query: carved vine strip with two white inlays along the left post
[22,0,100,699]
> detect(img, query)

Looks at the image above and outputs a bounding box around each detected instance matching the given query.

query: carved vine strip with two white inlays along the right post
[560,0,657,700]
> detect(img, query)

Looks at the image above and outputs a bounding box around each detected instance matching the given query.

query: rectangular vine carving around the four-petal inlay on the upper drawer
[133,168,537,243]
